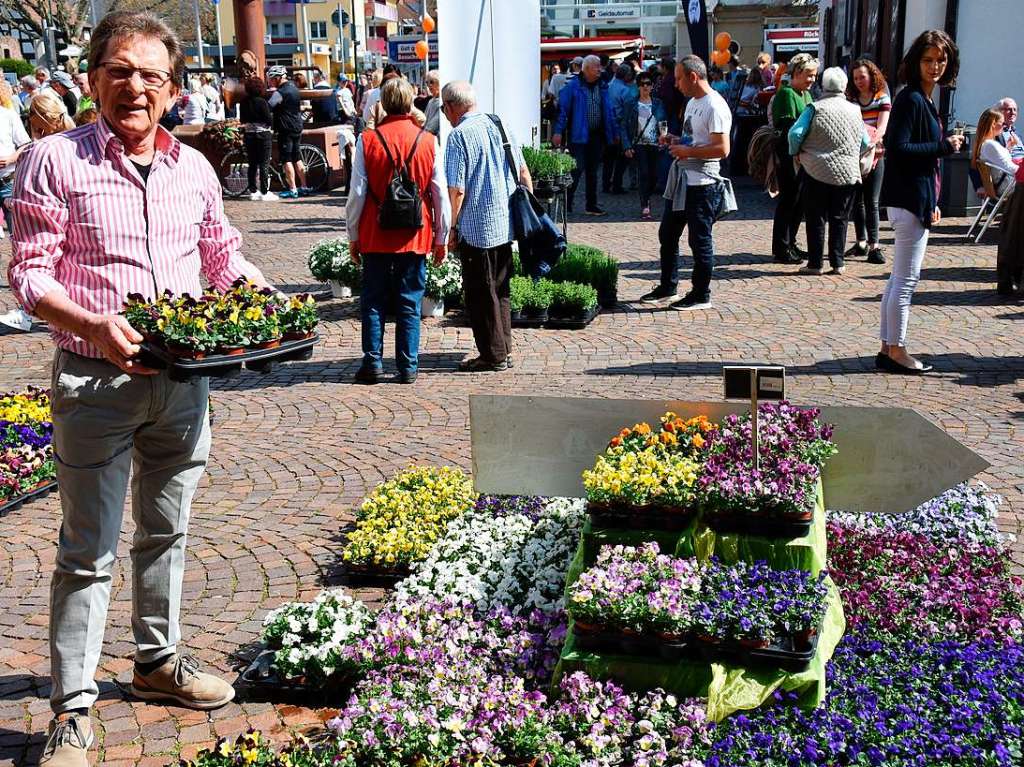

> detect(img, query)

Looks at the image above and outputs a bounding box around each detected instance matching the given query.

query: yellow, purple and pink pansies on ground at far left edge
[0,388,56,507]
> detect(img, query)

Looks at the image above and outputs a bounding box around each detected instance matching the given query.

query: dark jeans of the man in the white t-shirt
[657,184,722,300]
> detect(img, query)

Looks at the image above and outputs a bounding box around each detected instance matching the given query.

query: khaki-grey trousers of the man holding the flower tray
[50,350,210,713]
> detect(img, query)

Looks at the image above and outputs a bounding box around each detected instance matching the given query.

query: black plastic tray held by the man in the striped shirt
[137,333,319,381]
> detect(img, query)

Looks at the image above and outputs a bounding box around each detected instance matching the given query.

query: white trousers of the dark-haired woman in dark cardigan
[880,208,928,346]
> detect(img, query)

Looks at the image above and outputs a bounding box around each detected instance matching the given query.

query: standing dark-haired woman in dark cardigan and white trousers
[874,30,964,376]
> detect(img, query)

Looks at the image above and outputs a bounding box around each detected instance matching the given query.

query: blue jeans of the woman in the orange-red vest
[359,253,427,373]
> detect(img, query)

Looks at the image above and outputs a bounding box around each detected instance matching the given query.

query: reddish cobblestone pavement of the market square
[0,178,1024,767]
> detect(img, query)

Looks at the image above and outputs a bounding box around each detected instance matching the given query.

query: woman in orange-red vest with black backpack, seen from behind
[345,78,452,384]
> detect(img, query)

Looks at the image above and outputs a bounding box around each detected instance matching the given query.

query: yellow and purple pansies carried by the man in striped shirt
[124,280,318,359]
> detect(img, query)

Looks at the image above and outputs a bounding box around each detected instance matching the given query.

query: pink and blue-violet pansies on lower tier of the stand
[568,543,828,652]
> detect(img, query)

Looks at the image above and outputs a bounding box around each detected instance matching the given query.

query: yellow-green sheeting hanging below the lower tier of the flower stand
[553,579,846,721]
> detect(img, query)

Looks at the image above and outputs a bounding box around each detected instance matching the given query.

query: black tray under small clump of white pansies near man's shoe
[231,642,351,708]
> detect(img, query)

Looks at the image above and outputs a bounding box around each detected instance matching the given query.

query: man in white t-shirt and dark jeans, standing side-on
[640,55,732,311]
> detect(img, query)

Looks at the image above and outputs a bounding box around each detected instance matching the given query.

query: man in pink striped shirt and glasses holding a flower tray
[9,12,265,767]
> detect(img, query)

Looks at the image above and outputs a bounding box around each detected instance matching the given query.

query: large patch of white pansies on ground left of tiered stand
[395,497,585,612]
